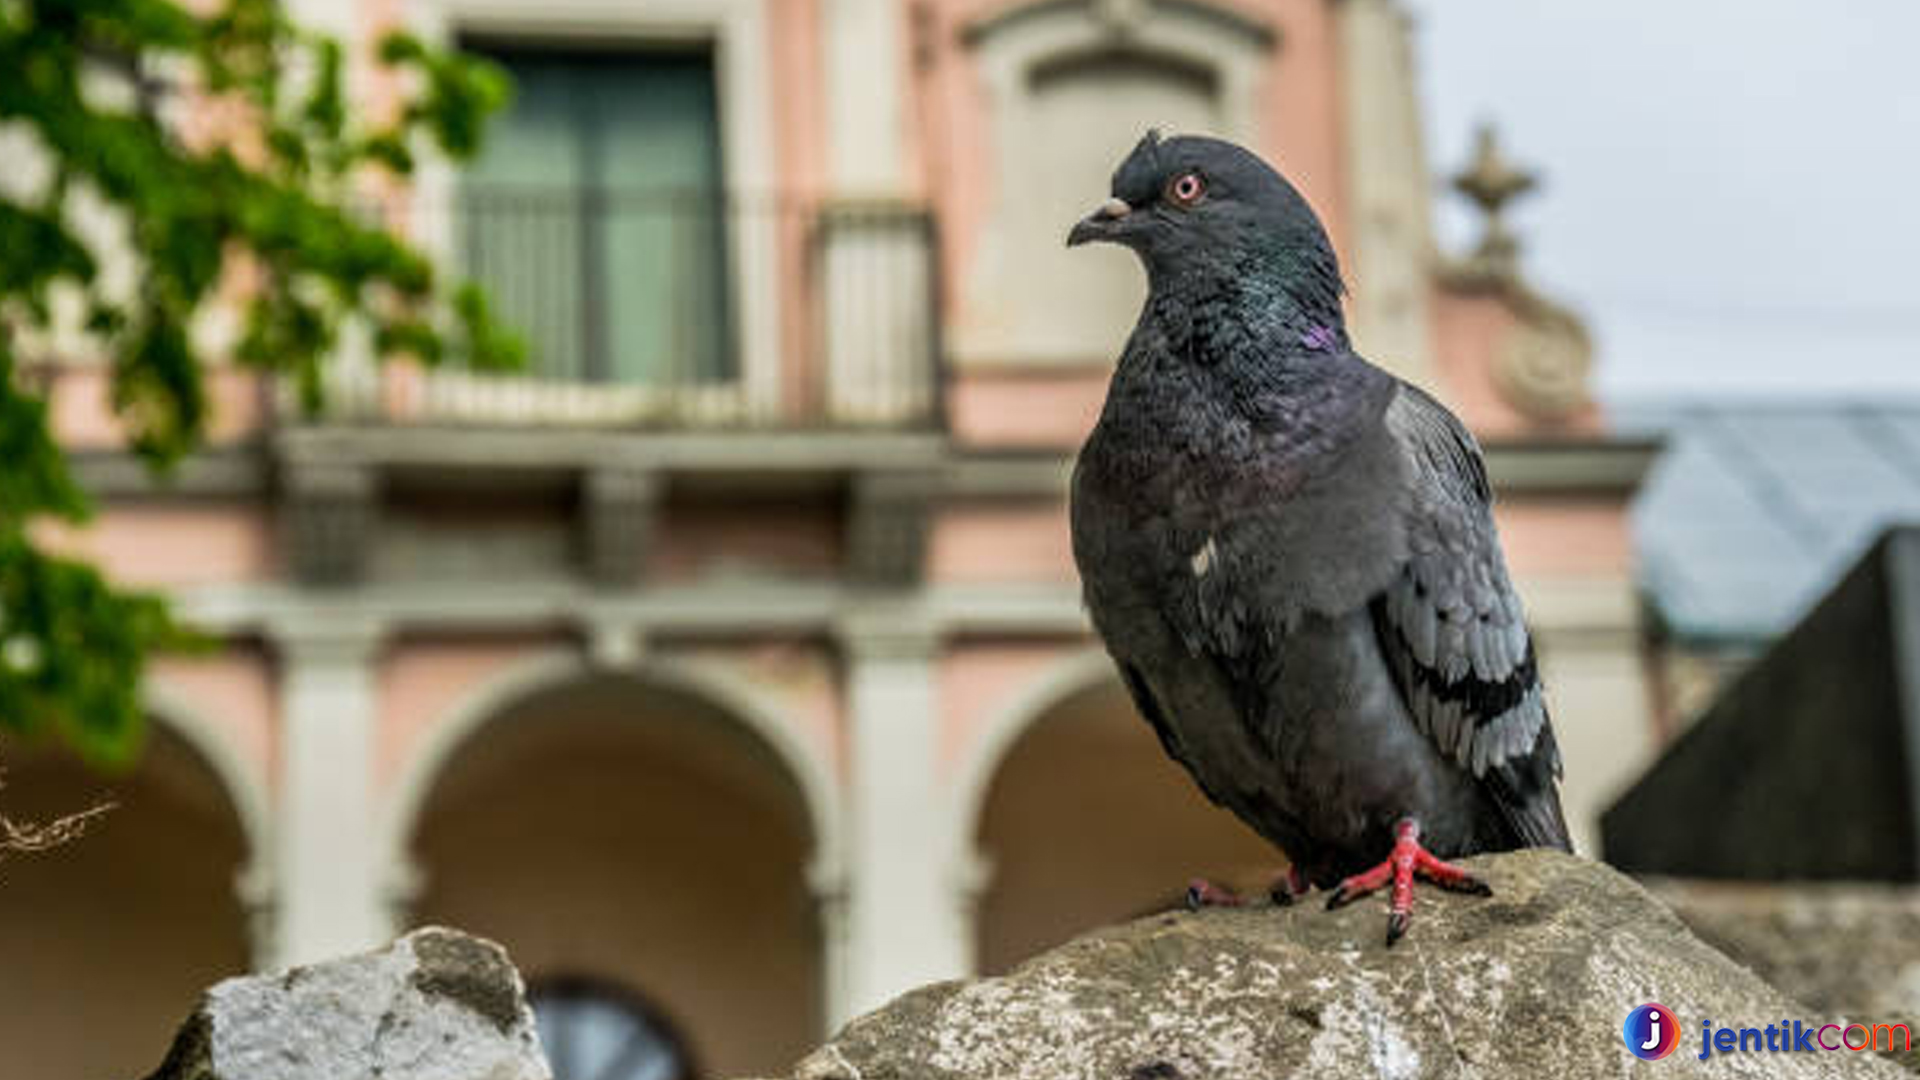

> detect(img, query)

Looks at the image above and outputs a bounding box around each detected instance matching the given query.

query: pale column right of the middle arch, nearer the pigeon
[829,617,972,1026]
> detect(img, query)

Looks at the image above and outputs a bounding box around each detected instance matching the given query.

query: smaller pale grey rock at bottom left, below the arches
[148,926,553,1080]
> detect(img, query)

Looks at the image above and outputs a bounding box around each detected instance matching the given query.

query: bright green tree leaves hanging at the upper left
[0,0,516,759]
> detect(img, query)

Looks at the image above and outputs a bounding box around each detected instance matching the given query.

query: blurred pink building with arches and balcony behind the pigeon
[0,0,1789,1080]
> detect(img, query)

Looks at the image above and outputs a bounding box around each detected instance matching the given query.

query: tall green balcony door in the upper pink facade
[461,42,735,386]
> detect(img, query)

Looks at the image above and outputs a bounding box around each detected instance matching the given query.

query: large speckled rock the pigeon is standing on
[793,851,1903,1080]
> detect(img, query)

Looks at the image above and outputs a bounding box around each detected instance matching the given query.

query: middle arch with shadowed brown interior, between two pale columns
[382,650,841,1074]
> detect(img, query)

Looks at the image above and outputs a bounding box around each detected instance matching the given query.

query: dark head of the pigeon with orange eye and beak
[1068,131,1340,321]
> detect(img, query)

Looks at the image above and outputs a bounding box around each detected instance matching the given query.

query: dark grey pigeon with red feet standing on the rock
[1068,133,1571,945]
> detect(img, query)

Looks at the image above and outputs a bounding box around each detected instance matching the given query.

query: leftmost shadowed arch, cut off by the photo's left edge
[0,682,255,1076]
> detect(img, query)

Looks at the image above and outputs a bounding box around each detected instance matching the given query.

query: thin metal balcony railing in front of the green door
[307,188,941,429]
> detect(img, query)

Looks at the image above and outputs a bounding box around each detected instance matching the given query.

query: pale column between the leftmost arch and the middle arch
[273,621,394,967]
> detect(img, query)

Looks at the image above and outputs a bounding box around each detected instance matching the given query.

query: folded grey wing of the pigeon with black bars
[1371,384,1571,849]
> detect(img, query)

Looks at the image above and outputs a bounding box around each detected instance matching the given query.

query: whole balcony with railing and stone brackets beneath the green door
[271,184,945,588]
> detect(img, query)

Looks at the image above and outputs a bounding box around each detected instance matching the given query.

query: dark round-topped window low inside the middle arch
[526,976,695,1080]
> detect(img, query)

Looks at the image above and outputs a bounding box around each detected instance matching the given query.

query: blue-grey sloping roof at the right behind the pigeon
[1620,400,1920,642]
